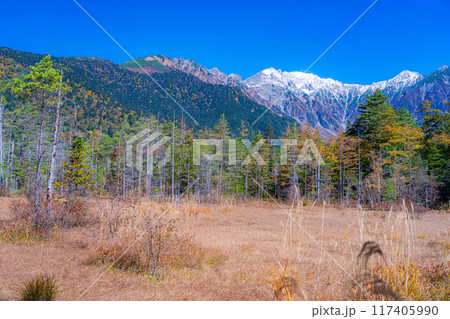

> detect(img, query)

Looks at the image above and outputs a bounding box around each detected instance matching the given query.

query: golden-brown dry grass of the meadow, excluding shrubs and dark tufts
[0,198,450,300]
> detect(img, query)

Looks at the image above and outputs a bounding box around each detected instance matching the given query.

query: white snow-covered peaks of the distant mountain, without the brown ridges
[244,68,422,134]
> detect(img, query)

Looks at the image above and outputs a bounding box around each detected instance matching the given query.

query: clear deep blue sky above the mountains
[0,0,450,84]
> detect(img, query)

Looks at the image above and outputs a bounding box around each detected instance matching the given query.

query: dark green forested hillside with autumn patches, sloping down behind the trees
[0,48,292,136]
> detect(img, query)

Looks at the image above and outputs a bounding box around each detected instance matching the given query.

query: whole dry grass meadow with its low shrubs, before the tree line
[0,197,450,300]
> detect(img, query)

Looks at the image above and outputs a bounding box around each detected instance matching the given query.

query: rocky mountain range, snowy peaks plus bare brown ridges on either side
[124,56,450,137]
